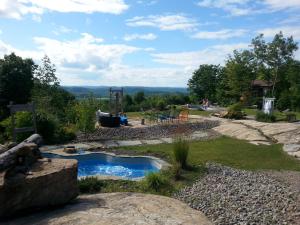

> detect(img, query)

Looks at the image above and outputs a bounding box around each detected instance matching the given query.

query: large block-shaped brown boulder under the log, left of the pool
[0,159,78,217]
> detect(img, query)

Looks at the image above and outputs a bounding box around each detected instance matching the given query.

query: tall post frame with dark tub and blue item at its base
[97,88,128,127]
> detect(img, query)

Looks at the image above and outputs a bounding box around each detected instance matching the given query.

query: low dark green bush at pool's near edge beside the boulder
[78,177,104,193]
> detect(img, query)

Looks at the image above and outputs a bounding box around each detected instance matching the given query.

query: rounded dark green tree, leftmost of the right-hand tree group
[188,64,221,101]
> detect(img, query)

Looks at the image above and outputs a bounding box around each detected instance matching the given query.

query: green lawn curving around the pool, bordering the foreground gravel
[79,137,300,195]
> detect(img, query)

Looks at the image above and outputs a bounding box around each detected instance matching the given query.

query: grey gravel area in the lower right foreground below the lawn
[175,163,300,225]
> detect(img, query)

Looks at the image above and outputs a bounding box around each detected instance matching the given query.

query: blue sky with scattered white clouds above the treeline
[0,0,300,87]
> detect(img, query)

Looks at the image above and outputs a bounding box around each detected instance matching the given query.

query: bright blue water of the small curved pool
[43,153,159,179]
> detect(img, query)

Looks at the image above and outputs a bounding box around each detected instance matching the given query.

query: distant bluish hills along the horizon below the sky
[63,86,188,98]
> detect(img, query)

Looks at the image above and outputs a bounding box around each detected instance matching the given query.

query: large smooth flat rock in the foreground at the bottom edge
[7,193,212,225]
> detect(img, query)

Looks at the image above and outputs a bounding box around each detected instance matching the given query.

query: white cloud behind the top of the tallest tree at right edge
[257,26,300,40]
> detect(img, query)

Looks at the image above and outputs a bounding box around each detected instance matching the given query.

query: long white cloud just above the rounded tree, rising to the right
[152,43,248,68]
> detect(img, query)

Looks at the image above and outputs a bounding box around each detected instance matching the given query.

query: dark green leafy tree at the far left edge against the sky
[0,53,34,119]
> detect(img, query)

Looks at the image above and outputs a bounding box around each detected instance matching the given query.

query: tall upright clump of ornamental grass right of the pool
[173,138,190,169]
